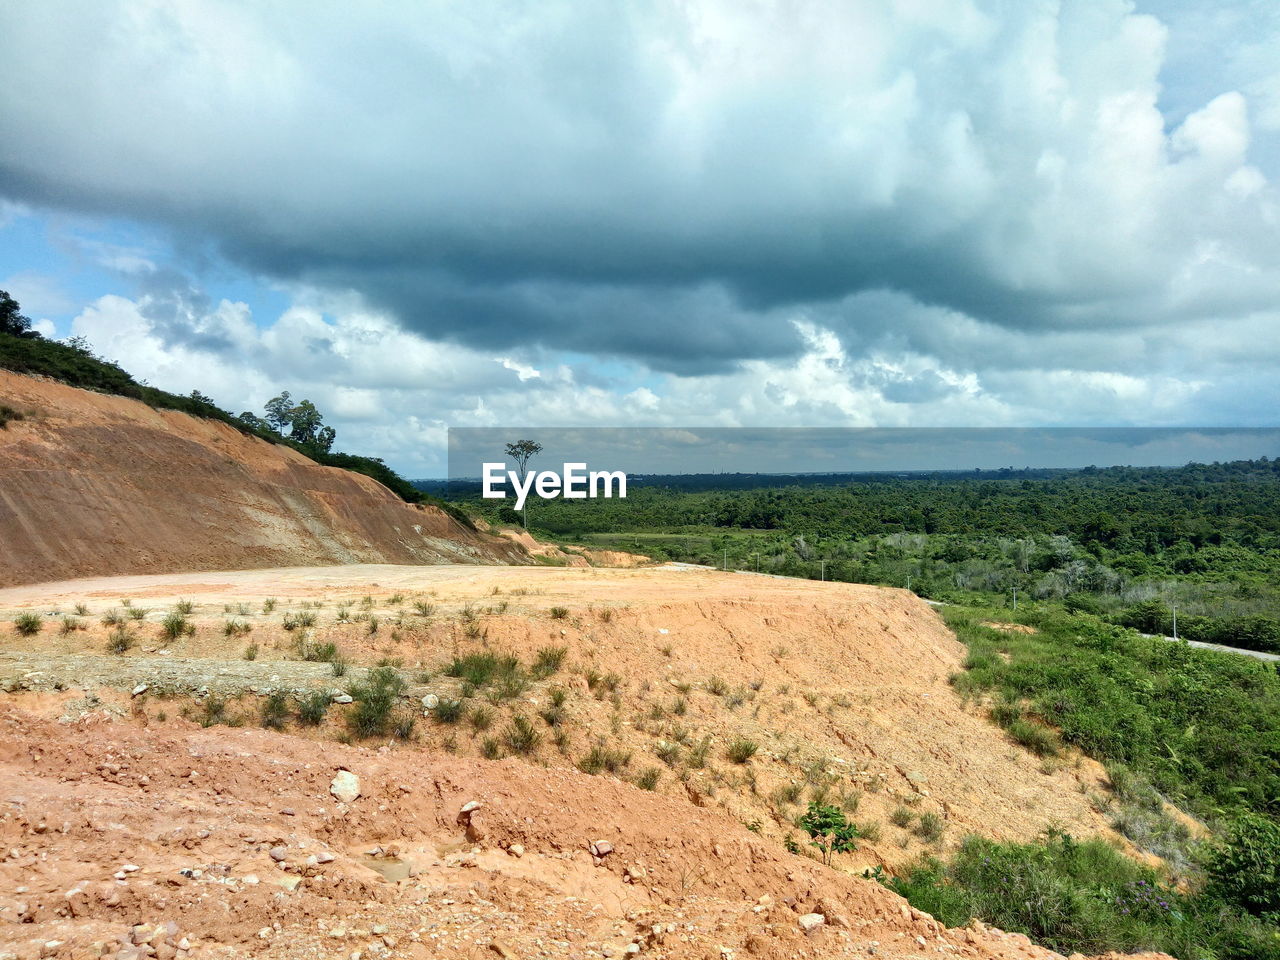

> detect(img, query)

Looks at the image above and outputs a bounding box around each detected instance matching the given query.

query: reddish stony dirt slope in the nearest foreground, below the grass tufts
[0,708,1172,960]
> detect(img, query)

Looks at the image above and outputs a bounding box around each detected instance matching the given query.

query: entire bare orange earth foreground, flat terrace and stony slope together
[0,564,1172,960]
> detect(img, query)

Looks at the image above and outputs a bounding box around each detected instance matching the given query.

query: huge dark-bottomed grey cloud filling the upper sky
[0,0,1280,378]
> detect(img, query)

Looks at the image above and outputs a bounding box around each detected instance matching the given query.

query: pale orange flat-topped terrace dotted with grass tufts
[0,566,1121,872]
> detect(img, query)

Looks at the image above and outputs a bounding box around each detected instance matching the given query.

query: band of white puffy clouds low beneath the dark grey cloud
[60,285,1280,476]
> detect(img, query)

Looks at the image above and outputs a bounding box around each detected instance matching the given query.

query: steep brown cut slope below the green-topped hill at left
[0,370,525,586]
